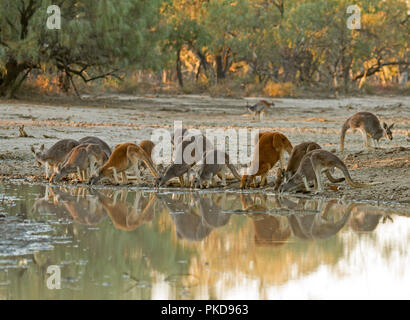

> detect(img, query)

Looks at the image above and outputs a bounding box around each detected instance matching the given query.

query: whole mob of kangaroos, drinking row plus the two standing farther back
[31,108,394,193]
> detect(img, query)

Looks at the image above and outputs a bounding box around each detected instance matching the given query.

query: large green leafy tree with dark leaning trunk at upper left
[0,0,167,96]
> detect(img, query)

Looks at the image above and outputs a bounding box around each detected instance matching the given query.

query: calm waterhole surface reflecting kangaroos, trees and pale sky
[0,184,410,299]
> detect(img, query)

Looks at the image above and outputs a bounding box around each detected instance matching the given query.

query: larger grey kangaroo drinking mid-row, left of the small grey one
[155,134,213,187]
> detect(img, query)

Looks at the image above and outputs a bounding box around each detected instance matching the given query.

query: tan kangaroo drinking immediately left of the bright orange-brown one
[50,144,107,182]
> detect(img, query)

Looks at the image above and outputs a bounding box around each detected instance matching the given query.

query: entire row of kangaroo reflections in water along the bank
[32,187,400,241]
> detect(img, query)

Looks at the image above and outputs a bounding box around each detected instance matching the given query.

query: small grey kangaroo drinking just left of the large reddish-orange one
[191,150,241,189]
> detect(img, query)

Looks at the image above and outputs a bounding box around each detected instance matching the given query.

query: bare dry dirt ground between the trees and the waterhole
[0,95,410,205]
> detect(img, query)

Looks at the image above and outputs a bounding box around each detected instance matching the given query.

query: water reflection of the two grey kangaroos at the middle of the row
[157,194,231,241]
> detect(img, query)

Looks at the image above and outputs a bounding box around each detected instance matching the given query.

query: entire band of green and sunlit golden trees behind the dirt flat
[0,0,410,97]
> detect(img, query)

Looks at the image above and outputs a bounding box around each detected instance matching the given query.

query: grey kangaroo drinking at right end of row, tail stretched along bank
[280,149,374,192]
